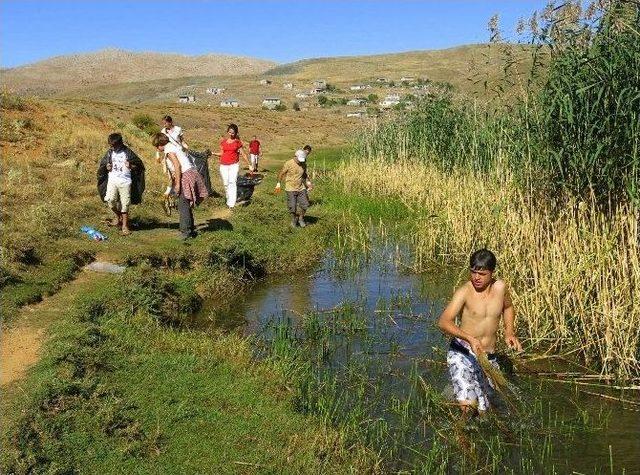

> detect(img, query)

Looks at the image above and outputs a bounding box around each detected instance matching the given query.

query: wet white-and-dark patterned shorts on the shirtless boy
[447,338,500,411]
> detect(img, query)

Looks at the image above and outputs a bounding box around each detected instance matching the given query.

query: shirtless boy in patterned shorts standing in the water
[438,249,522,412]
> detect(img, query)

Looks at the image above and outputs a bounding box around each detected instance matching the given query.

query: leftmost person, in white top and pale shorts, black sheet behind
[97,133,144,236]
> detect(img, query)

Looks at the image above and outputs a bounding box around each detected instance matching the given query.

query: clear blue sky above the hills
[0,0,547,67]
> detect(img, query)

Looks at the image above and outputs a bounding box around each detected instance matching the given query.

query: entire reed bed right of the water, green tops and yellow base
[337,0,640,378]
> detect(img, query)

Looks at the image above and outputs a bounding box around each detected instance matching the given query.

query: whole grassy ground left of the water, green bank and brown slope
[2,90,384,473]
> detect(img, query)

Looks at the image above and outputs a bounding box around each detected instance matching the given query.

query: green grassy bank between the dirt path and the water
[2,140,384,473]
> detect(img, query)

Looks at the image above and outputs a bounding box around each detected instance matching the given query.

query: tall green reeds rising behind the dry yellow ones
[356,1,640,208]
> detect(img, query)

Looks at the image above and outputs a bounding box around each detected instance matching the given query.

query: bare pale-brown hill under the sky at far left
[1,49,276,94]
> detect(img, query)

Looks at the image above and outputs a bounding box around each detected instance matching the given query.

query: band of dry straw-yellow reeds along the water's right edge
[338,159,640,379]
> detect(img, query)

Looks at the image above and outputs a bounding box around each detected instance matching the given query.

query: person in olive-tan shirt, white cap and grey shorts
[276,145,311,228]
